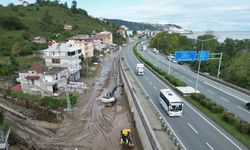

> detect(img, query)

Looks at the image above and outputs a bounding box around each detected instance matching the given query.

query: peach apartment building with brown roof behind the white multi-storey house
[67,34,94,58]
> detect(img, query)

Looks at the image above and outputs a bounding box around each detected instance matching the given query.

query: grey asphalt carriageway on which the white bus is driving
[124,43,247,150]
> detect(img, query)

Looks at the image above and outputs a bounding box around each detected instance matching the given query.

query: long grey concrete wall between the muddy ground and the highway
[119,49,161,150]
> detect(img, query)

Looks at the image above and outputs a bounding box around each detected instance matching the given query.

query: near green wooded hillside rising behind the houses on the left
[0,1,124,55]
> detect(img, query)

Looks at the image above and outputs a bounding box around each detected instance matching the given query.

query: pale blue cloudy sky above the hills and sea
[0,0,250,31]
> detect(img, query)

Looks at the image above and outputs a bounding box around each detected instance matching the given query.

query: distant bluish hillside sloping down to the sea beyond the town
[105,19,182,31]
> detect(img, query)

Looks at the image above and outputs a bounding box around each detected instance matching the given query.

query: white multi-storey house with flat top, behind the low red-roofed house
[43,43,82,81]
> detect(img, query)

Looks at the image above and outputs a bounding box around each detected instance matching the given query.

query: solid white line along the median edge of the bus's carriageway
[150,69,242,150]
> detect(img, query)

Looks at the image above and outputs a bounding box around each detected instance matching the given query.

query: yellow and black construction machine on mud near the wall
[120,128,134,149]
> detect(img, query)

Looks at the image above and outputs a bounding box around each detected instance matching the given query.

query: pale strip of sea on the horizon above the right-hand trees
[187,31,250,42]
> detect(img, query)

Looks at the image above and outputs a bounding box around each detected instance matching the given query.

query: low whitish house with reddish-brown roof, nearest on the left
[17,63,69,96]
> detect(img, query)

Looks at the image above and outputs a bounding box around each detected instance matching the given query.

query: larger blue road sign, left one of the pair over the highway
[175,51,196,61]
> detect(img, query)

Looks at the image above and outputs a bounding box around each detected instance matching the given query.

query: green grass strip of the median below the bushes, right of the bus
[185,97,250,148]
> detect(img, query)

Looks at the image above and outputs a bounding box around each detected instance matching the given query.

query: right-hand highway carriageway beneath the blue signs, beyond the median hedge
[138,44,250,122]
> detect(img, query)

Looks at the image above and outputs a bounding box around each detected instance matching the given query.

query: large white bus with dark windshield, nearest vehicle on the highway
[159,89,183,116]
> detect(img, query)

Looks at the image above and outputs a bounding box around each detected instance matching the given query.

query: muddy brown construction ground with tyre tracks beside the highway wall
[0,52,143,150]
